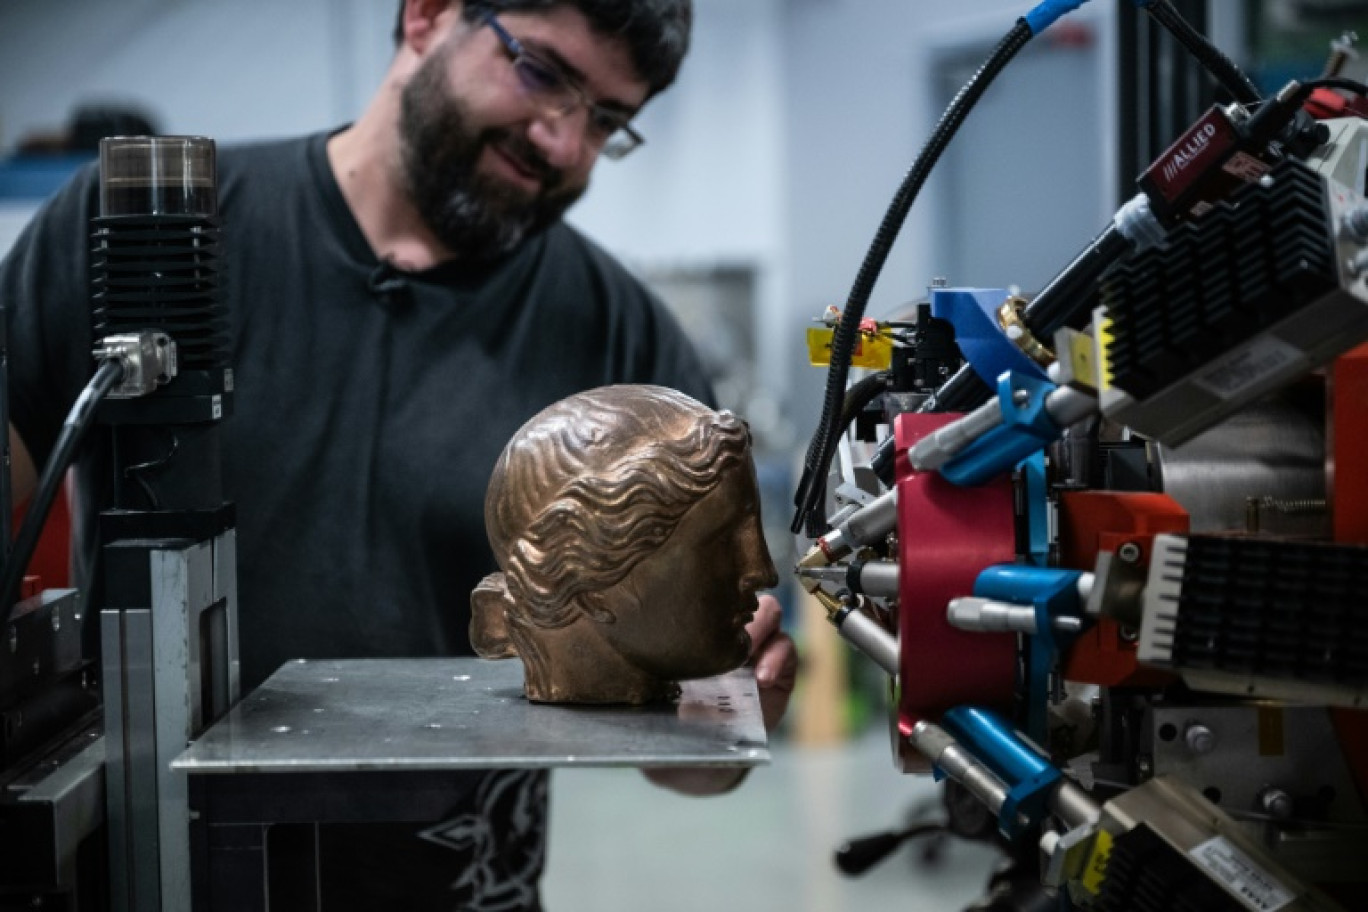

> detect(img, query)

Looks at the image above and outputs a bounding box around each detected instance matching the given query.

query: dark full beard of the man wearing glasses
[399,44,584,261]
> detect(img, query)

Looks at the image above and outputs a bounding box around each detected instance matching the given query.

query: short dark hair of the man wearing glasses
[394,0,694,96]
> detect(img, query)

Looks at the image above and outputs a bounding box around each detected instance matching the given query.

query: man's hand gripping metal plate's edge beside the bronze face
[642,595,798,794]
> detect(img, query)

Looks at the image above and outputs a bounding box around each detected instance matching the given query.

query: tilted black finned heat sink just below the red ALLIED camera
[1101,160,1339,399]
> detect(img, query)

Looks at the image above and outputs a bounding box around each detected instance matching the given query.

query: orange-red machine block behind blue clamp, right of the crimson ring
[1059,491,1189,688]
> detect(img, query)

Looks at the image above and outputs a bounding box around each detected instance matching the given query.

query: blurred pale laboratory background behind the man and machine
[0,0,1368,912]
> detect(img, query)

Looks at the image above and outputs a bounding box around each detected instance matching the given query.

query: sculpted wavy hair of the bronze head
[477,386,750,648]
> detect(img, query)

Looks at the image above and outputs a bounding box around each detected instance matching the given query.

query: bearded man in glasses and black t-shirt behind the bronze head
[0,0,795,912]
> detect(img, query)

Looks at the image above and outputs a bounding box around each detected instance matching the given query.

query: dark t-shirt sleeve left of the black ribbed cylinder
[0,165,97,469]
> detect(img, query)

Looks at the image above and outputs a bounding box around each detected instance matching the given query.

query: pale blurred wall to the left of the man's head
[0,0,393,148]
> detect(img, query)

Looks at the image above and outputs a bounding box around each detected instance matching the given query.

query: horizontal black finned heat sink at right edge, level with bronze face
[1171,536,1368,686]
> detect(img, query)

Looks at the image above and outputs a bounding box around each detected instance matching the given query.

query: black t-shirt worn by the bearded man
[8,134,711,909]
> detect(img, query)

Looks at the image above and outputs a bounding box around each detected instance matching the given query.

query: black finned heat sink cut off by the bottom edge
[1092,823,1248,912]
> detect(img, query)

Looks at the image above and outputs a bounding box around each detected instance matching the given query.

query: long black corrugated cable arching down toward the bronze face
[791,18,1033,535]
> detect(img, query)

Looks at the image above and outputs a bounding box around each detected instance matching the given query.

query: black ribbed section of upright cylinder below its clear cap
[92,215,228,372]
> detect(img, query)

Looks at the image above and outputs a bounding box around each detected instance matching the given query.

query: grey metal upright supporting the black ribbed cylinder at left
[100,531,238,912]
